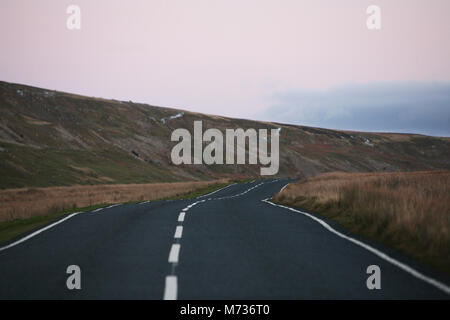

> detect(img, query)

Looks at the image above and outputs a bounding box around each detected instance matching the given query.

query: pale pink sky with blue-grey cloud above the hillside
[0,0,450,136]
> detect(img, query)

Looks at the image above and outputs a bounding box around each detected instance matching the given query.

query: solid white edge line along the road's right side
[262,199,450,295]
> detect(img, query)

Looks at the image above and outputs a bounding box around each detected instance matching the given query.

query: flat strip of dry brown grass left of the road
[0,180,227,221]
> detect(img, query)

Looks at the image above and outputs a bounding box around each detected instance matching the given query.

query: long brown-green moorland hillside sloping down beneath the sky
[0,82,450,189]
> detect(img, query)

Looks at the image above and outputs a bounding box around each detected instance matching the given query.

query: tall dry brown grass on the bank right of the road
[275,171,450,273]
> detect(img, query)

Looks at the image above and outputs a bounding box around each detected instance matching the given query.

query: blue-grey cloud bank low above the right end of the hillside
[262,83,450,136]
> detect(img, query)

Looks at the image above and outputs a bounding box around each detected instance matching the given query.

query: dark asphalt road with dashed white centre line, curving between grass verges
[0,180,450,299]
